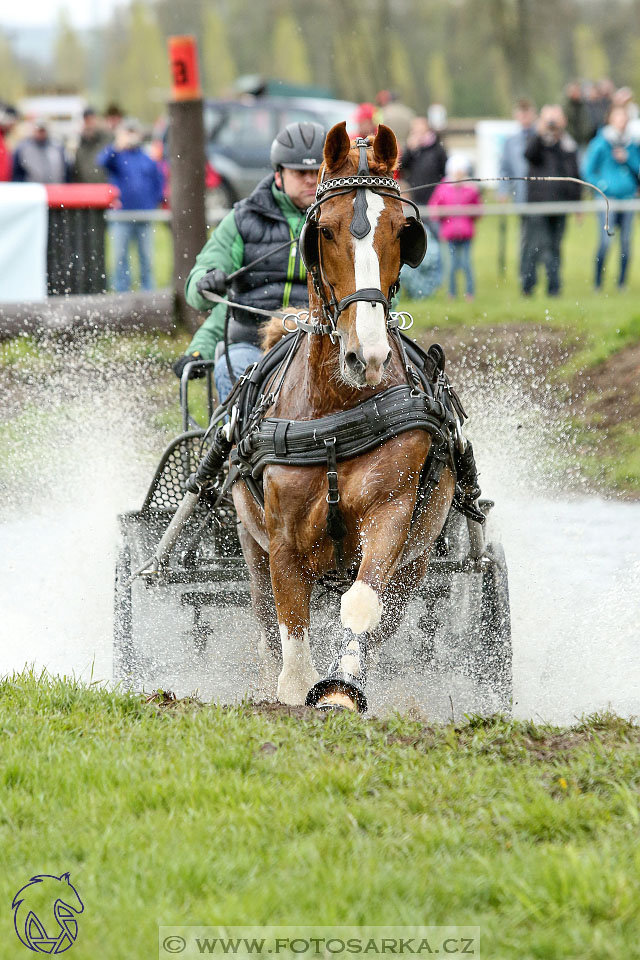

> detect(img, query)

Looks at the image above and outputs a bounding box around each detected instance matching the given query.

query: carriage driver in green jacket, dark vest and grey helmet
[173,123,325,400]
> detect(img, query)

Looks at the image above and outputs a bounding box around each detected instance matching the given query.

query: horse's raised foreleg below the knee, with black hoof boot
[305,630,367,713]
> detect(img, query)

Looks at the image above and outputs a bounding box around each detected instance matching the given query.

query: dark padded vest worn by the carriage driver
[228,174,309,343]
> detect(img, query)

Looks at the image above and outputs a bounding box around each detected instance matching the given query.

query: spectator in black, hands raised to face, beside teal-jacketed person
[521,105,580,297]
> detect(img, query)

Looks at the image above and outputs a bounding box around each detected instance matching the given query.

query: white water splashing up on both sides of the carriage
[0,338,640,723]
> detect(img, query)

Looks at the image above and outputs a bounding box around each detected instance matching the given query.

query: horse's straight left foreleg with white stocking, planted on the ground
[270,545,320,704]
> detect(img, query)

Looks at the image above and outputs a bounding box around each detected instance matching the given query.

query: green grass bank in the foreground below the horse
[0,674,640,960]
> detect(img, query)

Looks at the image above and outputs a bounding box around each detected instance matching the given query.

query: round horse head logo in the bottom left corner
[11,873,84,955]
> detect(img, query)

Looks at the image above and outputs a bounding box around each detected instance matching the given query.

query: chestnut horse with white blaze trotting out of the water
[233,123,455,708]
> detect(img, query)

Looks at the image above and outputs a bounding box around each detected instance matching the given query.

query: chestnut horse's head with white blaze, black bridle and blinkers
[301,122,426,388]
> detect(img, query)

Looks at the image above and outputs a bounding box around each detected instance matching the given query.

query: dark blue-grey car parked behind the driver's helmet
[204,97,358,207]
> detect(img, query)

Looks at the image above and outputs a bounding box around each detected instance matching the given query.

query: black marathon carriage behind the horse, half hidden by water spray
[113,363,511,719]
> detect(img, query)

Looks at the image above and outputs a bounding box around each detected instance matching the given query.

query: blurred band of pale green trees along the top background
[0,0,640,121]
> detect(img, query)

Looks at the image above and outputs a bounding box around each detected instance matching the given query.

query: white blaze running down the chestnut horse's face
[353,190,389,364]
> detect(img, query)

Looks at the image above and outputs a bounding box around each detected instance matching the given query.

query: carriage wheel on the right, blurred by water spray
[475,543,512,712]
